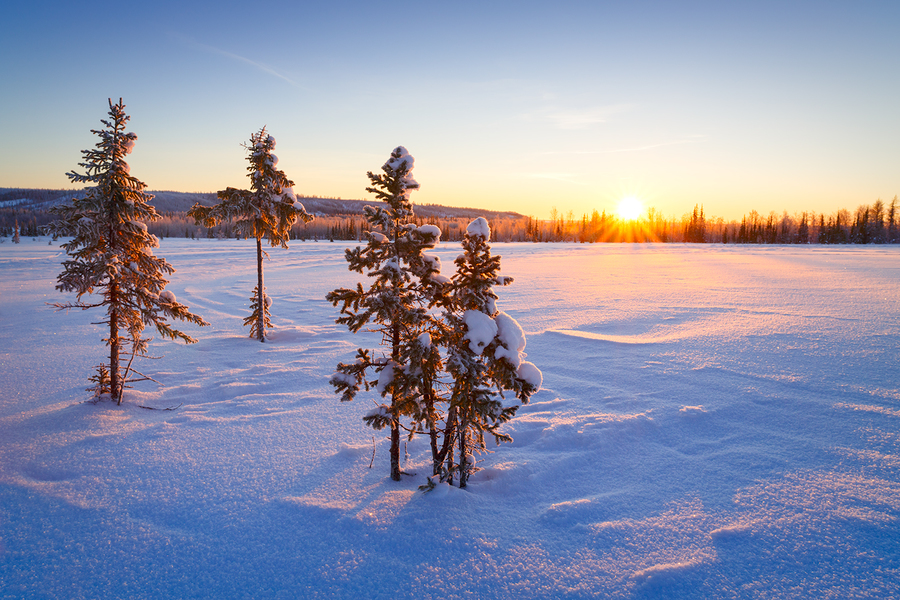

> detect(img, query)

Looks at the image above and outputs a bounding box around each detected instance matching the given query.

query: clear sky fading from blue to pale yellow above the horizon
[0,0,900,220]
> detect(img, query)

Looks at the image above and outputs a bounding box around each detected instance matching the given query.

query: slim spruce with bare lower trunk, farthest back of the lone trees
[188,127,313,342]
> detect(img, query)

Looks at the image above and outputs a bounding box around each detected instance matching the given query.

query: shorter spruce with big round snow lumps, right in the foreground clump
[444,217,542,488]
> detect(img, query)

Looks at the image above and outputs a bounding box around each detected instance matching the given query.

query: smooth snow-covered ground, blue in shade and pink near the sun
[0,239,900,599]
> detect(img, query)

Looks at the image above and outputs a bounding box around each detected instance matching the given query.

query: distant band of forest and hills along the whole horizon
[0,188,900,244]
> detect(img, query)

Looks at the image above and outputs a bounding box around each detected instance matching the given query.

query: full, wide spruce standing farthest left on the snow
[46,99,207,404]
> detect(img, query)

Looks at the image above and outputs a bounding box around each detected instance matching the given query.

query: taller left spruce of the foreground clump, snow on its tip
[327,146,449,481]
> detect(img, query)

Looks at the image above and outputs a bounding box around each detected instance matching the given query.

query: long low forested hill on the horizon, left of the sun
[0,188,522,220]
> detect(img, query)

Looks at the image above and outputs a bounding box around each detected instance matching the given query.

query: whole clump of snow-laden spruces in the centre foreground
[327,146,541,487]
